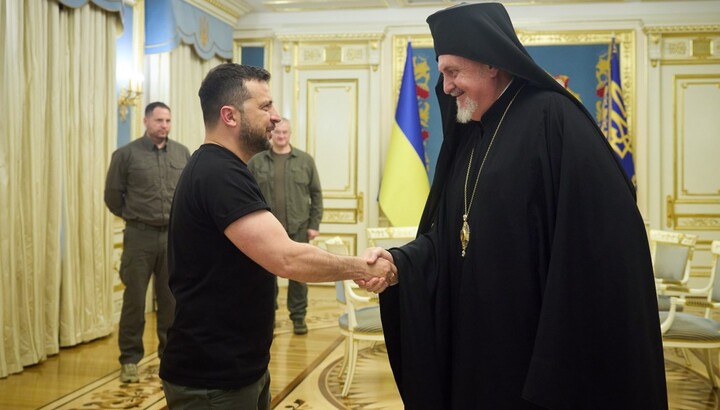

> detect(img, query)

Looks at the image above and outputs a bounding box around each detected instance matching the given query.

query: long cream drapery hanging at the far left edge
[0,0,120,377]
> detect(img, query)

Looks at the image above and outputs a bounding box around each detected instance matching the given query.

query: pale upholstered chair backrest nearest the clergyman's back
[650,229,697,284]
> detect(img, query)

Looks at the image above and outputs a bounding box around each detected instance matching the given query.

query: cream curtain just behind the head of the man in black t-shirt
[167,43,226,153]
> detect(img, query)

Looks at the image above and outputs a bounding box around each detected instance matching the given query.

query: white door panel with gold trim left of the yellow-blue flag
[278,34,382,247]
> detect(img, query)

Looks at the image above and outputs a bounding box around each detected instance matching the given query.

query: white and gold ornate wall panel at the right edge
[645,26,720,276]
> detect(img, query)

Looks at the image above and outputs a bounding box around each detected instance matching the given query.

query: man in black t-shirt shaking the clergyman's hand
[160,63,396,409]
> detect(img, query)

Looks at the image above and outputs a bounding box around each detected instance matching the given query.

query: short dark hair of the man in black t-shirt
[198,63,270,128]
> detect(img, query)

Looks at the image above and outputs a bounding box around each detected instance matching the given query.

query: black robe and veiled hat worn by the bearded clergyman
[380,3,667,410]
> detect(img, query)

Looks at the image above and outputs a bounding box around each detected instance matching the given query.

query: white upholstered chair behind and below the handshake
[325,237,385,397]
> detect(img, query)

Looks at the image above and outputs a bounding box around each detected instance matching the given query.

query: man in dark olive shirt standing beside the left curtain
[105,101,190,383]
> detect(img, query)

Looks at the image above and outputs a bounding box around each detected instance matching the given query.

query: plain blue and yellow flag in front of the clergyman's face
[380,42,430,226]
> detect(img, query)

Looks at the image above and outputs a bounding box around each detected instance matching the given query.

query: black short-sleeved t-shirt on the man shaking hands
[160,144,275,389]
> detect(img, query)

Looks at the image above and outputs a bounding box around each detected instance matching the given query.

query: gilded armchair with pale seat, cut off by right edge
[660,241,720,388]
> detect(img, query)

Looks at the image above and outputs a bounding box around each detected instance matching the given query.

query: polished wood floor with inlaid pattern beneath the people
[0,286,720,410]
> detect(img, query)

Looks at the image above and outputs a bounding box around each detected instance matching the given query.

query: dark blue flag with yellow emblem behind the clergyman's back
[600,37,637,187]
